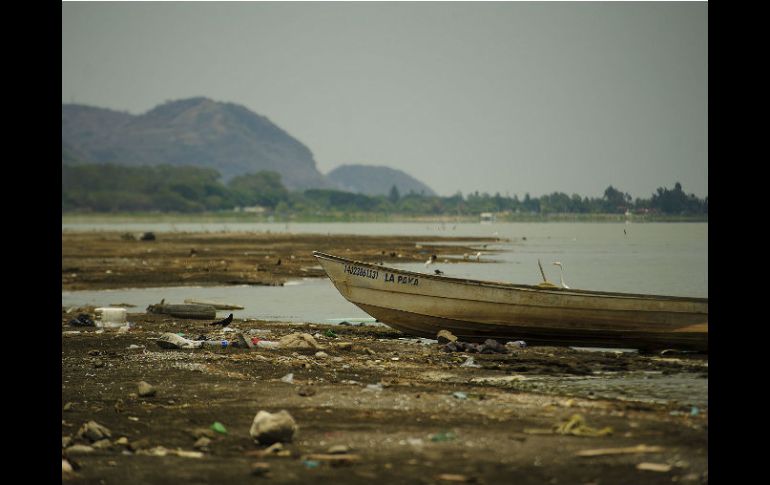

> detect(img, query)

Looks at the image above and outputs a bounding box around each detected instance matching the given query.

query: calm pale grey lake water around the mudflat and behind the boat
[62,222,708,323]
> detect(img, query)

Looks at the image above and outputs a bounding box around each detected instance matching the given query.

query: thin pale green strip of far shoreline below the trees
[62,212,708,224]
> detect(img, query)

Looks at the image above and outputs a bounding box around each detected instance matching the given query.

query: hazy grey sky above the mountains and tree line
[62,2,708,198]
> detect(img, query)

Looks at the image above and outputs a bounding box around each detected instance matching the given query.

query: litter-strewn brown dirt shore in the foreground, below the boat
[62,309,708,484]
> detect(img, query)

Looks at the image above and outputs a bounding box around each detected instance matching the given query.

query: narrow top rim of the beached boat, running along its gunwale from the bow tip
[313,251,708,303]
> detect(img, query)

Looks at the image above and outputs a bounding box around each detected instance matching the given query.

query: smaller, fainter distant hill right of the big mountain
[327,165,436,195]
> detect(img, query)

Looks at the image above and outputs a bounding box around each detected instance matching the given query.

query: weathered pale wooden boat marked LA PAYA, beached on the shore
[313,251,708,352]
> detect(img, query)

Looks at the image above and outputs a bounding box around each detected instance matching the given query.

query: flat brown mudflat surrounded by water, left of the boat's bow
[62,231,497,290]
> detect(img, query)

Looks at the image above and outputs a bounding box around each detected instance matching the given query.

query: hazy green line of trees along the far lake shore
[62,164,708,215]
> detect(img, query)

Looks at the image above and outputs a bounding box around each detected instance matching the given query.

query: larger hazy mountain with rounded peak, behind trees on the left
[62,97,334,190]
